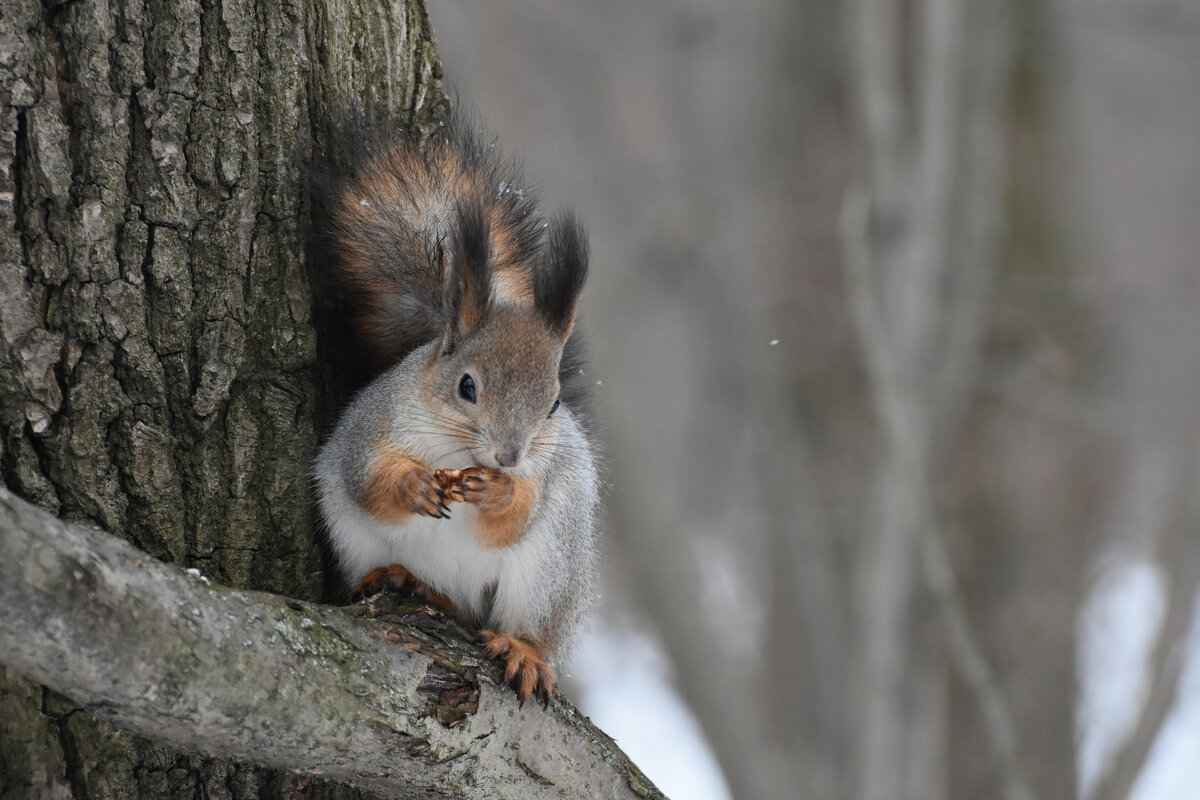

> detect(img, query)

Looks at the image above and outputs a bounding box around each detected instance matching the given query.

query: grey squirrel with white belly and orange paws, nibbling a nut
[313,121,600,708]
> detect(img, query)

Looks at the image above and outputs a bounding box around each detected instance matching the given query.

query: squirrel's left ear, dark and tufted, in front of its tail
[439,200,492,355]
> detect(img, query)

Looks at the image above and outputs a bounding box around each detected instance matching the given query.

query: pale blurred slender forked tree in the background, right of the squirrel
[841,0,1032,800]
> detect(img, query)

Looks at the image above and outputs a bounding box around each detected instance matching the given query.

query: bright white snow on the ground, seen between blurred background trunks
[569,561,1200,800]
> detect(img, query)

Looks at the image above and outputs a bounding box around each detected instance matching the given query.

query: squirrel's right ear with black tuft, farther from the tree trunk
[533,212,588,341]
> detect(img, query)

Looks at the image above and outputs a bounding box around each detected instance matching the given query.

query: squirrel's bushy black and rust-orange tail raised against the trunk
[326,119,544,368]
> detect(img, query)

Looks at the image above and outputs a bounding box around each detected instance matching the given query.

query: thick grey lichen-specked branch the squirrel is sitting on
[0,489,662,798]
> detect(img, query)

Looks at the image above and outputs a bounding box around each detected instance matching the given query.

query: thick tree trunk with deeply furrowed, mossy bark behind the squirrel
[0,0,445,798]
